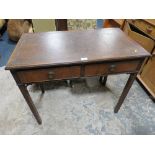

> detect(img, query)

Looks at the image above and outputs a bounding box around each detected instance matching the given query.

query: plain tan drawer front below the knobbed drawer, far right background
[124,22,155,52]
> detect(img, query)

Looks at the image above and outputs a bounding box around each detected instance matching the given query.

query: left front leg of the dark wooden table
[18,85,42,124]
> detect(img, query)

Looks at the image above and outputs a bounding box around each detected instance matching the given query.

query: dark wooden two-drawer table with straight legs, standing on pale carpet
[6,28,150,124]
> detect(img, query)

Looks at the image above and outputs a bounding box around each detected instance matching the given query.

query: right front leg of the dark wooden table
[114,73,137,113]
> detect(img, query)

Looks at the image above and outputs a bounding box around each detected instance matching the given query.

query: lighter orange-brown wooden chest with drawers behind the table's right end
[123,19,155,99]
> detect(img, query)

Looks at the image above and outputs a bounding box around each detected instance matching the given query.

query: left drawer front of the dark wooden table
[17,66,80,83]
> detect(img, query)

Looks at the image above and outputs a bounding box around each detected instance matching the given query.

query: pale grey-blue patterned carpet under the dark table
[0,68,155,135]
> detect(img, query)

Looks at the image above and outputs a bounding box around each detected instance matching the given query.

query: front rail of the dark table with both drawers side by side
[16,60,141,84]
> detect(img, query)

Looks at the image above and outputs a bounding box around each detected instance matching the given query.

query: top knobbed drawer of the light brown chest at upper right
[130,19,155,39]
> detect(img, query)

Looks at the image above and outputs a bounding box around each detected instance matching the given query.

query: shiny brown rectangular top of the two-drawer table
[6,28,149,70]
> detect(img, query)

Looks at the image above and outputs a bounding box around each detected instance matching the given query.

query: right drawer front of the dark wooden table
[84,60,140,76]
